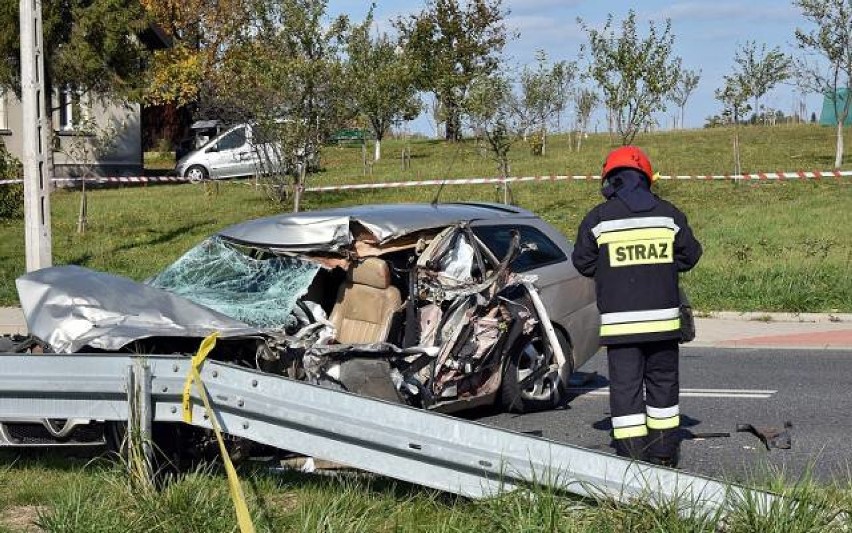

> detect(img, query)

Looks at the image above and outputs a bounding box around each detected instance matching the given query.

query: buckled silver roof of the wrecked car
[219,203,535,249]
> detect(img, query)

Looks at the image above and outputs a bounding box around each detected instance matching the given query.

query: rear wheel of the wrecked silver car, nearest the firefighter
[500,329,573,413]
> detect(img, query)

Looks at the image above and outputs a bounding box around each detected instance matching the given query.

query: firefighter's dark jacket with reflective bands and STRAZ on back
[571,189,702,345]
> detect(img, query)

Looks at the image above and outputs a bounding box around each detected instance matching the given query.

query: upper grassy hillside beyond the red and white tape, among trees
[315,124,852,184]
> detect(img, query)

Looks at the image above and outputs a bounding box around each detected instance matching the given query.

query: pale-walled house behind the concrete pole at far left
[0,25,171,177]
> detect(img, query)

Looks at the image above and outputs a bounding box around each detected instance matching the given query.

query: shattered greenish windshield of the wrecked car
[147,237,319,328]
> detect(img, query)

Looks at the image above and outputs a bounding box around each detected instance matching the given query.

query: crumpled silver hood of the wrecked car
[15,266,262,352]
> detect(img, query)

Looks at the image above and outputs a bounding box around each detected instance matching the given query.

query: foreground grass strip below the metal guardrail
[0,446,852,533]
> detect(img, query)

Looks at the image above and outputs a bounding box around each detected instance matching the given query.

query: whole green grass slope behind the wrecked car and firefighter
[0,125,852,312]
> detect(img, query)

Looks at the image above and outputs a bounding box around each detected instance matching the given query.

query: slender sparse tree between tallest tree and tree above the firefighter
[520,50,577,155]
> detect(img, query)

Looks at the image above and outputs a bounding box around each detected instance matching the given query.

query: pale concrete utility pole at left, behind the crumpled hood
[19,0,53,272]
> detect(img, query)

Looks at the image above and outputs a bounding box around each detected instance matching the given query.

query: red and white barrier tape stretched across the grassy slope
[0,170,852,192]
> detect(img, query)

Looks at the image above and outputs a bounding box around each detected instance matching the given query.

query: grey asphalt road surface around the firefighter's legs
[477,347,852,484]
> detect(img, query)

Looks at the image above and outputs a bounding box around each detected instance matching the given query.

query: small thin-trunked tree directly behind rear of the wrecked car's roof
[464,74,518,186]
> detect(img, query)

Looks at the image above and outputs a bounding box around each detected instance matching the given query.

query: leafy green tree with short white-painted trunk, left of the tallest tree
[347,13,422,161]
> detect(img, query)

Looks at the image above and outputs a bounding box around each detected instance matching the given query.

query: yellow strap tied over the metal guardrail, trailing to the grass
[183,333,255,533]
